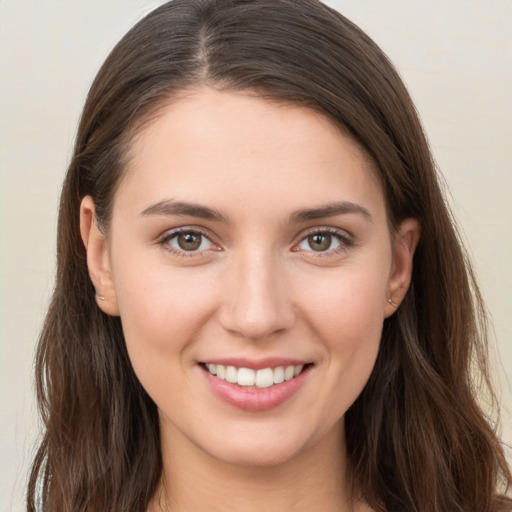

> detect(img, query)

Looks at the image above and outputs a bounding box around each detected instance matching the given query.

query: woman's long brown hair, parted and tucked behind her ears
[28,0,512,512]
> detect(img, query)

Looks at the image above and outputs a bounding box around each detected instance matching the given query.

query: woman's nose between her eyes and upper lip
[220,249,296,340]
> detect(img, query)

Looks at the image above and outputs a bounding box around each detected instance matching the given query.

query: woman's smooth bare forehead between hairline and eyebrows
[116,88,384,222]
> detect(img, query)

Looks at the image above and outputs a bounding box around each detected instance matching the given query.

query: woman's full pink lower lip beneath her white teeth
[201,366,312,412]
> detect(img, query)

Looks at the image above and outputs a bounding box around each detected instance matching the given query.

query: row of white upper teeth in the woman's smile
[206,364,304,388]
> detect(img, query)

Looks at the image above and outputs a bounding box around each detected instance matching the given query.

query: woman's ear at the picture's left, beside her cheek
[80,196,119,316]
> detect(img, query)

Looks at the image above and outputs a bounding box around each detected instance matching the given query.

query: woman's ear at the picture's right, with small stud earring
[384,219,421,318]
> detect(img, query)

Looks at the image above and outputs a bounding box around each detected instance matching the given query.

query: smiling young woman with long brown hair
[28,0,511,512]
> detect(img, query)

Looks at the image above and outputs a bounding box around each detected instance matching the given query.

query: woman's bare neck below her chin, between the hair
[149,425,366,512]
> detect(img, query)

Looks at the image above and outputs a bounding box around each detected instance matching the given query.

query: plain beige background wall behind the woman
[0,0,512,512]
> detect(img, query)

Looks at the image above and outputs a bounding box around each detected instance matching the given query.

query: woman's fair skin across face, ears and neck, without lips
[81,88,419,512]
